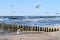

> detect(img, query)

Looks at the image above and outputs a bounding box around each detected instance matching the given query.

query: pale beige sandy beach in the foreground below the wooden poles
[0,31,60,40]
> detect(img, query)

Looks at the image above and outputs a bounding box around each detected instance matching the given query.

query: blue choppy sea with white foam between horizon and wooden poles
[0,16,60,26]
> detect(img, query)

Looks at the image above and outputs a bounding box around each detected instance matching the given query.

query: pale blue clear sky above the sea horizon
[0,0,60,16]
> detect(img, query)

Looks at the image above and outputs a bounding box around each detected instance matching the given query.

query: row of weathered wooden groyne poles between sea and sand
[0,23,59,32]
